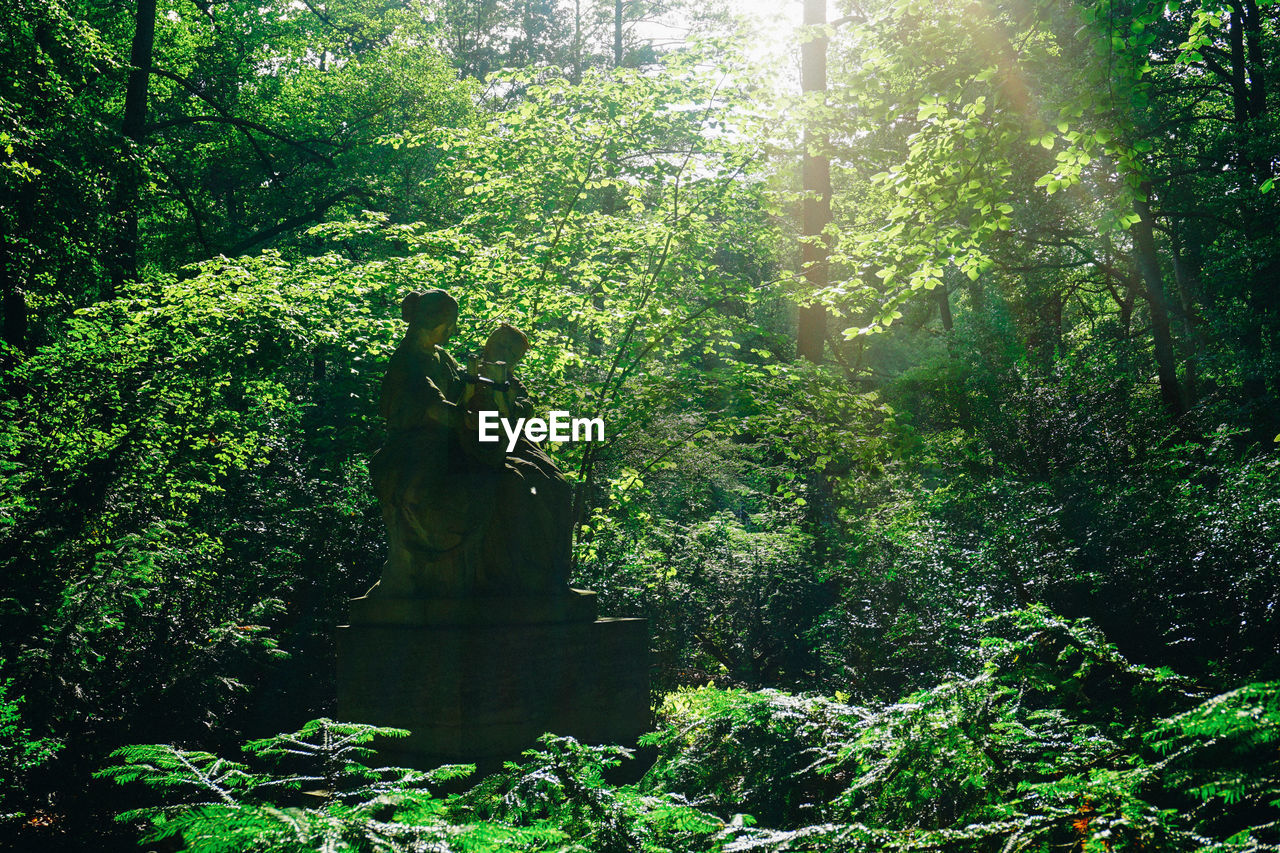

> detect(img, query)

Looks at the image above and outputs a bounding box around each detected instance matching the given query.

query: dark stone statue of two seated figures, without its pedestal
[370,289,572,598]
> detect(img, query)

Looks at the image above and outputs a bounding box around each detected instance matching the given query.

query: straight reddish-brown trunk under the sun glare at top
[796,0,831,364]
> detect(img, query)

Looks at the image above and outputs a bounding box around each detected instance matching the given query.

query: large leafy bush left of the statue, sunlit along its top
[0,249,398,758]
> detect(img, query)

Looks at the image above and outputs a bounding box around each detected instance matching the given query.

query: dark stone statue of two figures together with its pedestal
[335,291,649,768]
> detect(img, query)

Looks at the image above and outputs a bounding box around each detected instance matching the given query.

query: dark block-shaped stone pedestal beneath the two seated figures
[338,590,649,767]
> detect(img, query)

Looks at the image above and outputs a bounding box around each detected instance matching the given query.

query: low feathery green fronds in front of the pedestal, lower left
[97,719,724,853]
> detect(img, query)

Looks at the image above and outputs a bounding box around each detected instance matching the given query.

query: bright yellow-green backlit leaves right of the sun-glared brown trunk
[806,0,1192,337]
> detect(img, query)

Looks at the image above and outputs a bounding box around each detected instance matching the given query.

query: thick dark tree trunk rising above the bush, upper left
[110,0,156,298]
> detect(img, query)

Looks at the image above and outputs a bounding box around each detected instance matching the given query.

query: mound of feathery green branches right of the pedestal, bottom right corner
[644,608,1280,850]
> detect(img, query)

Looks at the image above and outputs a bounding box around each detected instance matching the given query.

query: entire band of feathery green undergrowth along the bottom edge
[102,608,1280,852]
